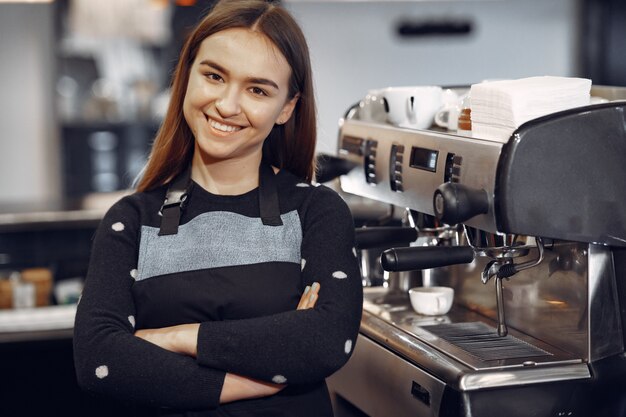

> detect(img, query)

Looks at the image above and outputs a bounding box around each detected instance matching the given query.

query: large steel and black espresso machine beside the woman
[329,86,626,417]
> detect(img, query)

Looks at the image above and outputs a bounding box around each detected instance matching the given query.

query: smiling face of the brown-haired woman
[183,28,297,162]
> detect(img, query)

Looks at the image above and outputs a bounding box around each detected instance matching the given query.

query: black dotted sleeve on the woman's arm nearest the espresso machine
[197,183,363,384]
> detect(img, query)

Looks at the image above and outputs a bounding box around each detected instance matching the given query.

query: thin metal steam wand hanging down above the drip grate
[480,237,543,337]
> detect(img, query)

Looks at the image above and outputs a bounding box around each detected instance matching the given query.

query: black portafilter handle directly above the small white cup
[380,246,474,272]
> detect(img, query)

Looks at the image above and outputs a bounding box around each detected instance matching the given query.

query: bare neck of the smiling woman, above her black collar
[191,152,261,195]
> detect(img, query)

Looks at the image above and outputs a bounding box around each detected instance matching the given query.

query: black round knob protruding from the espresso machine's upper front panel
[433,182,489,224]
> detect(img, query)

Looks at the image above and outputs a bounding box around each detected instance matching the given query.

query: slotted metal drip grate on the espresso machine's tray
[421,322,552,361]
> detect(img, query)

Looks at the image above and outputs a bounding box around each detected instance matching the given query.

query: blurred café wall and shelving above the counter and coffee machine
[0,0,626,204]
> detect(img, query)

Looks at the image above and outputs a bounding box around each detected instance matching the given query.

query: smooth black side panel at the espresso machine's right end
[495,102,626,246]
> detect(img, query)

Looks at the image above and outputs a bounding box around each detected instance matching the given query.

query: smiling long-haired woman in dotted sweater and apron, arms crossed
[74,1,362,417]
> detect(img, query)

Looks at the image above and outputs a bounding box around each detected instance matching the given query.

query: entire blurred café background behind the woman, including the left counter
[0,0,626,416]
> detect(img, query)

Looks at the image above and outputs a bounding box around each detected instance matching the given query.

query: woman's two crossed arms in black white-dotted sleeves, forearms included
[74,187,362,409]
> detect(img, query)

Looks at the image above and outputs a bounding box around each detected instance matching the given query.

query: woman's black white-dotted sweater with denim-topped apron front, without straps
[74,170,362,417]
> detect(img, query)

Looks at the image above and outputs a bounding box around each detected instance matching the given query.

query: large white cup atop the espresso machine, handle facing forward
[383,86,443,129]
